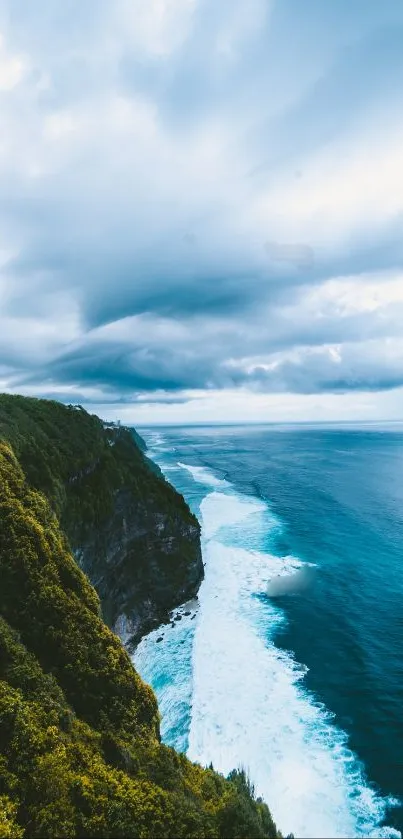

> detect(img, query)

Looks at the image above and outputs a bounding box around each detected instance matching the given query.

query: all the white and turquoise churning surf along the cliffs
[136,434,400,836]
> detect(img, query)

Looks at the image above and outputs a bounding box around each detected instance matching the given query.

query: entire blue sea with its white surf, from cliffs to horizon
[134,424,403,837]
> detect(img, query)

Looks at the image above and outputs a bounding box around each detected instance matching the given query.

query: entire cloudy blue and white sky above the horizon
[0,0,403,425]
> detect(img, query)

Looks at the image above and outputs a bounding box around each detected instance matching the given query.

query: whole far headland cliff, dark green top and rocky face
[0,394,203,644]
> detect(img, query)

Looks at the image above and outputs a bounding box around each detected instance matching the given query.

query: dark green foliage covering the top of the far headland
[0,394,195,546]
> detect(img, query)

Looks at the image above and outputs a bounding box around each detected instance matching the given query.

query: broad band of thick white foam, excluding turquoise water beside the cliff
[188,492,400,837]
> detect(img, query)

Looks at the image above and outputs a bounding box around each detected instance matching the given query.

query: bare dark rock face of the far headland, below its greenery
[76,490,203,647]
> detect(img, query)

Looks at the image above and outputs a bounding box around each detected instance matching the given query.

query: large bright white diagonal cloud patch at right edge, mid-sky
[251,112,403,253]
